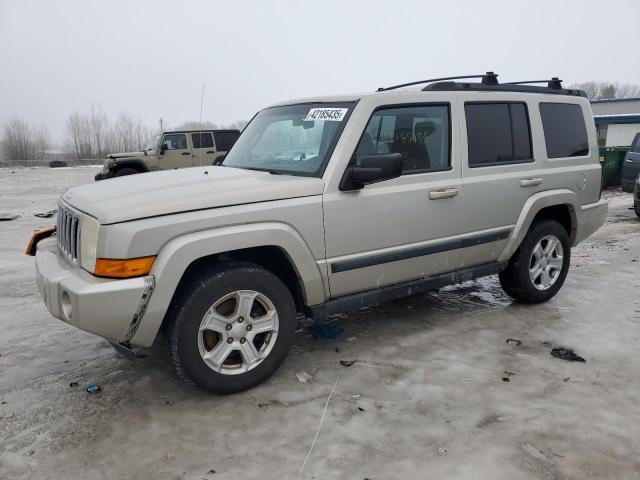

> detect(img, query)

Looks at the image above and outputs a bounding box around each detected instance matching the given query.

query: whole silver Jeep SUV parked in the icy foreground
[27,72,607,393]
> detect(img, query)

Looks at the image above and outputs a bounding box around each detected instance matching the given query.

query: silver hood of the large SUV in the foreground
[62,166,324,225]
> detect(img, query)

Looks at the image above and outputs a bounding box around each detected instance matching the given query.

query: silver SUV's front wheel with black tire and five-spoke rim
[169,262,296,394]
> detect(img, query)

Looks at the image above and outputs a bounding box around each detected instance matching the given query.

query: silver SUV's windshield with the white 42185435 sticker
[223,102,355,177]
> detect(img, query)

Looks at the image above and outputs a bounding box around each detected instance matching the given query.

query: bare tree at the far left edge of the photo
[2,117,49,160]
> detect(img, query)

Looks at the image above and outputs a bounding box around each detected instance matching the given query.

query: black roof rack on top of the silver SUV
[377,72,587,97]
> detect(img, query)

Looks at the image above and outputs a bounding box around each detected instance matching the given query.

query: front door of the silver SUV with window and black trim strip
[324,102,463,297]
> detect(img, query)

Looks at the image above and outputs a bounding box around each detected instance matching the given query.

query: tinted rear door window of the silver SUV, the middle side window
[464,102,533,167]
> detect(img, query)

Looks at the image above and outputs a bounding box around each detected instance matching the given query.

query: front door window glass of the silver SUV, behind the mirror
[355,105,450,175]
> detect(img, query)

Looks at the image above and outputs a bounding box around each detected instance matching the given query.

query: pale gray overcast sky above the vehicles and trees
[0,0,640,142]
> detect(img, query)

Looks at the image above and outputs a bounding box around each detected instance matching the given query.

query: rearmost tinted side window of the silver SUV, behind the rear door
[540,103,589,158]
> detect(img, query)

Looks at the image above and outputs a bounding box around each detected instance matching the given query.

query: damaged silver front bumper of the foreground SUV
[36,238,153,344]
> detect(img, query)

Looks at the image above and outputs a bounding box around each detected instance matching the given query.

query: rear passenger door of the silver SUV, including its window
[460,93,545,264]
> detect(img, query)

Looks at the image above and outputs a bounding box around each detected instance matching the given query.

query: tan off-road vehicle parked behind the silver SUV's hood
[95,130,240,180]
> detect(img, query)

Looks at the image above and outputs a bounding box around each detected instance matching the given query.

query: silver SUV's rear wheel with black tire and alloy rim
[500,220,571,303]
